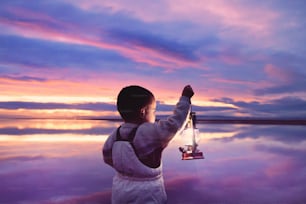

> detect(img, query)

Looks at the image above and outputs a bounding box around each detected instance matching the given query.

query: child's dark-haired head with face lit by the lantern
[117,86,156,123]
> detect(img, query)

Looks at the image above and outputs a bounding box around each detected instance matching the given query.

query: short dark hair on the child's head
[117,86,154,121]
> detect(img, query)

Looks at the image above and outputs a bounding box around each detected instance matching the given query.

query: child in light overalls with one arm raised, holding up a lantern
[103,85,194,204]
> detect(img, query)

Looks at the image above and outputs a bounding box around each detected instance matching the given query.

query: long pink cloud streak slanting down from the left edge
[0,9,196,70]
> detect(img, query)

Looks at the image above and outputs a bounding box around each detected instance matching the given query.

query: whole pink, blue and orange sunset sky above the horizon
[0,0,306,118]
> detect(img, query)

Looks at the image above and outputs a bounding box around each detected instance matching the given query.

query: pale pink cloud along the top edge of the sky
[67,0,281,47]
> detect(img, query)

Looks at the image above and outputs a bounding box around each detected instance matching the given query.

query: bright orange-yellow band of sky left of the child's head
[0,75,114,103]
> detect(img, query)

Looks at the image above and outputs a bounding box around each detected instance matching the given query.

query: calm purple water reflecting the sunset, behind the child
[0,120,306,204]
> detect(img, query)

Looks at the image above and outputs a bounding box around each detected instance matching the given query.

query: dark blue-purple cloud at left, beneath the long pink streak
[0,36,129,72]
